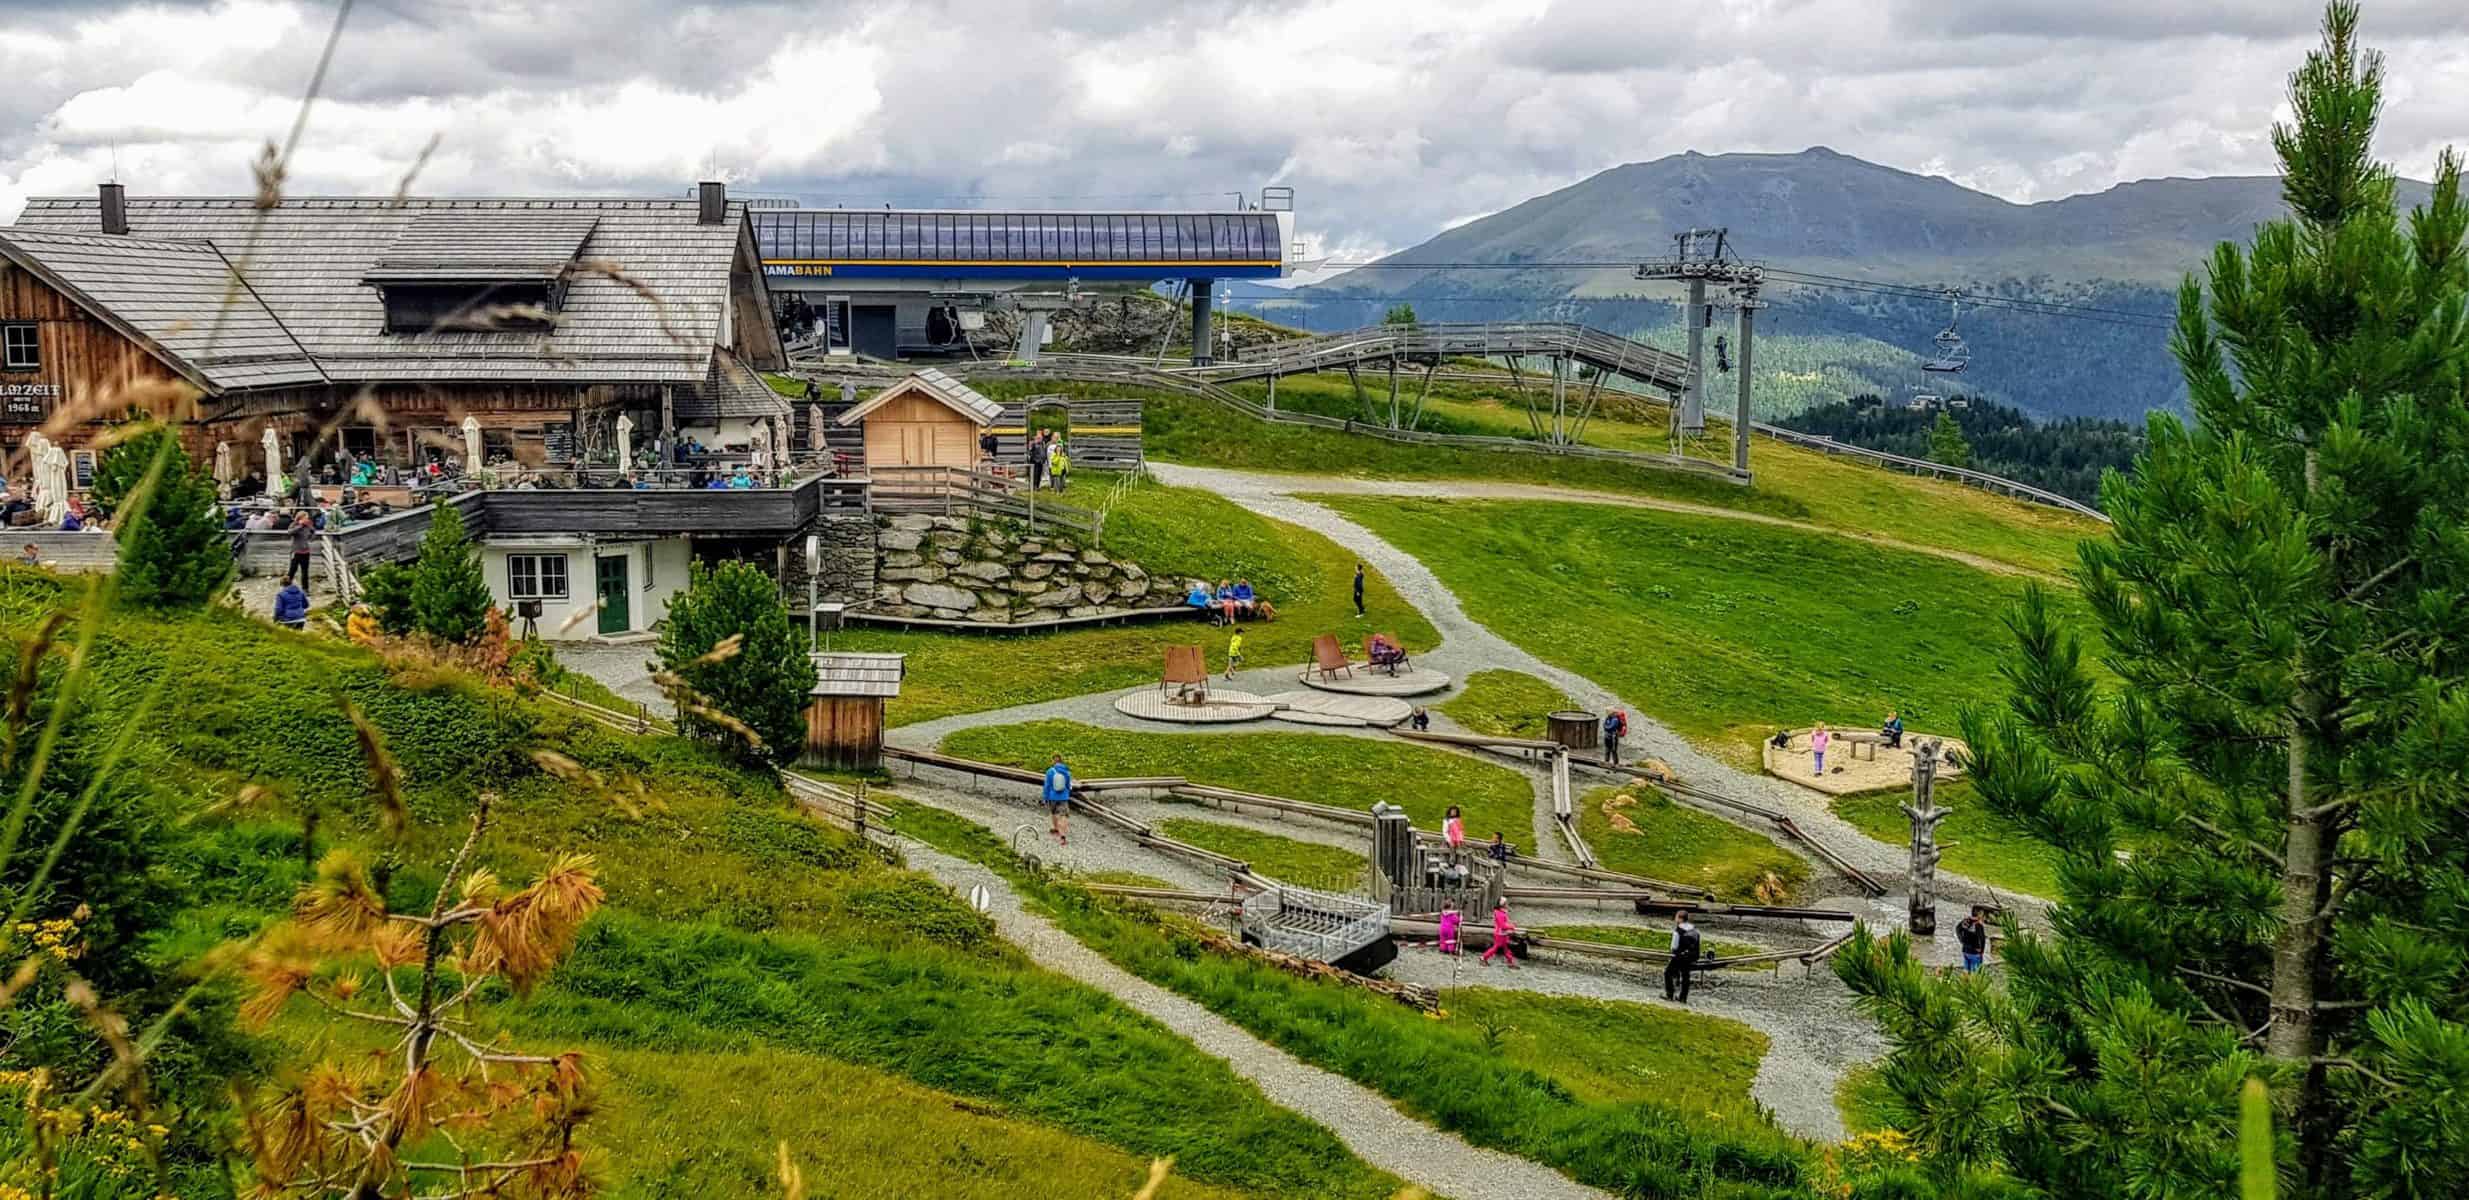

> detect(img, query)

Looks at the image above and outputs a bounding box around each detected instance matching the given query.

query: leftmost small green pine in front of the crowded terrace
[111,430,232,610]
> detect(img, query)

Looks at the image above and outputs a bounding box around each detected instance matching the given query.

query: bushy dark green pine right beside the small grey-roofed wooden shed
[659,563,815,763]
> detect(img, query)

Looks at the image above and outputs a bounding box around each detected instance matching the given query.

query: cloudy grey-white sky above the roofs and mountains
[0,0,2469,257]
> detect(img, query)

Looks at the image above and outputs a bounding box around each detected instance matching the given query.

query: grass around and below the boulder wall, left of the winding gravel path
[832,481,1439,723]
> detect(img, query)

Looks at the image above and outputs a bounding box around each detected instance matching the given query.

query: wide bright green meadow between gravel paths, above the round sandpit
[1328,496,2071,763]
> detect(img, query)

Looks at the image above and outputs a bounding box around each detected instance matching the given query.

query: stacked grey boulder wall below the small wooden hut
[872,516,1170,625]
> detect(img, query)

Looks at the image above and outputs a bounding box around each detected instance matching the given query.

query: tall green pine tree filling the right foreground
[1837,0,2469,1198]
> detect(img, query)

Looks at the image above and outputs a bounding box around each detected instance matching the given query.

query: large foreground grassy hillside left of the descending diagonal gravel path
[14,570,1395,1198]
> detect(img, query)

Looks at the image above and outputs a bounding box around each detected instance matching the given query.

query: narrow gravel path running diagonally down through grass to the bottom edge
[888,829,1612,1200]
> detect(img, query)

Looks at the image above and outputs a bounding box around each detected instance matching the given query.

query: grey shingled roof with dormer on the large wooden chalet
[0,198,748,390]
